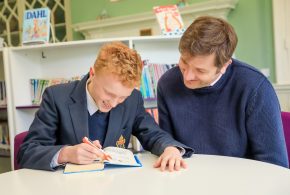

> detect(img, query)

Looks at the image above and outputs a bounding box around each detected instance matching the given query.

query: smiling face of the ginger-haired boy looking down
[88,71,134,112]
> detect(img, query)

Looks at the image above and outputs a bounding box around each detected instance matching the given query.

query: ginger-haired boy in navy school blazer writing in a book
[18,42,192,171]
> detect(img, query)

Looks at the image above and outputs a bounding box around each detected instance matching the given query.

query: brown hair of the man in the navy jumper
[179,16,238,68]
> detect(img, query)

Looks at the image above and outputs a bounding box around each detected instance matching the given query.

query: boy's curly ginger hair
[94,42,143,87]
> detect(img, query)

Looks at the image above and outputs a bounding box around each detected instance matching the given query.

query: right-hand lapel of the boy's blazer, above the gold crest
[103,104,124,147]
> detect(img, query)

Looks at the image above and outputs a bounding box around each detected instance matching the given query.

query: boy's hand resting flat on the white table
[154,146,187,172]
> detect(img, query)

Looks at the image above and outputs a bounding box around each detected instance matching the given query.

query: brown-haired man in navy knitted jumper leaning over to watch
[157,16,288,167]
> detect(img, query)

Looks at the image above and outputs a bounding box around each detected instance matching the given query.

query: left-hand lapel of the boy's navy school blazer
[69,75,89,143]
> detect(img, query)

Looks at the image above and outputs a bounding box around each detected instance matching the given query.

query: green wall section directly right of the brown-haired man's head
[228,0,275,81]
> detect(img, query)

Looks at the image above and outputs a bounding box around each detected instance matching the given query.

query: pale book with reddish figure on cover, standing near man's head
[153,5,185,35]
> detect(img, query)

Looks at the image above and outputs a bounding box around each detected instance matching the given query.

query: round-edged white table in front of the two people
[0,153,290,195]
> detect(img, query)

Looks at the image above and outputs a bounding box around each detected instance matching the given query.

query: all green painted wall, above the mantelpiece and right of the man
[71,0,275,82]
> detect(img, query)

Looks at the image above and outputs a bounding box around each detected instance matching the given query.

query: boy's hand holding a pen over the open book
[58,140,105,164]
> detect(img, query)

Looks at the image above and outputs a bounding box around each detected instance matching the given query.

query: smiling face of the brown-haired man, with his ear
[179,54,231,89]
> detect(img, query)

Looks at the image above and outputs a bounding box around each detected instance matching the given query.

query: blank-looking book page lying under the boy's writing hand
[63,162,104,173]
